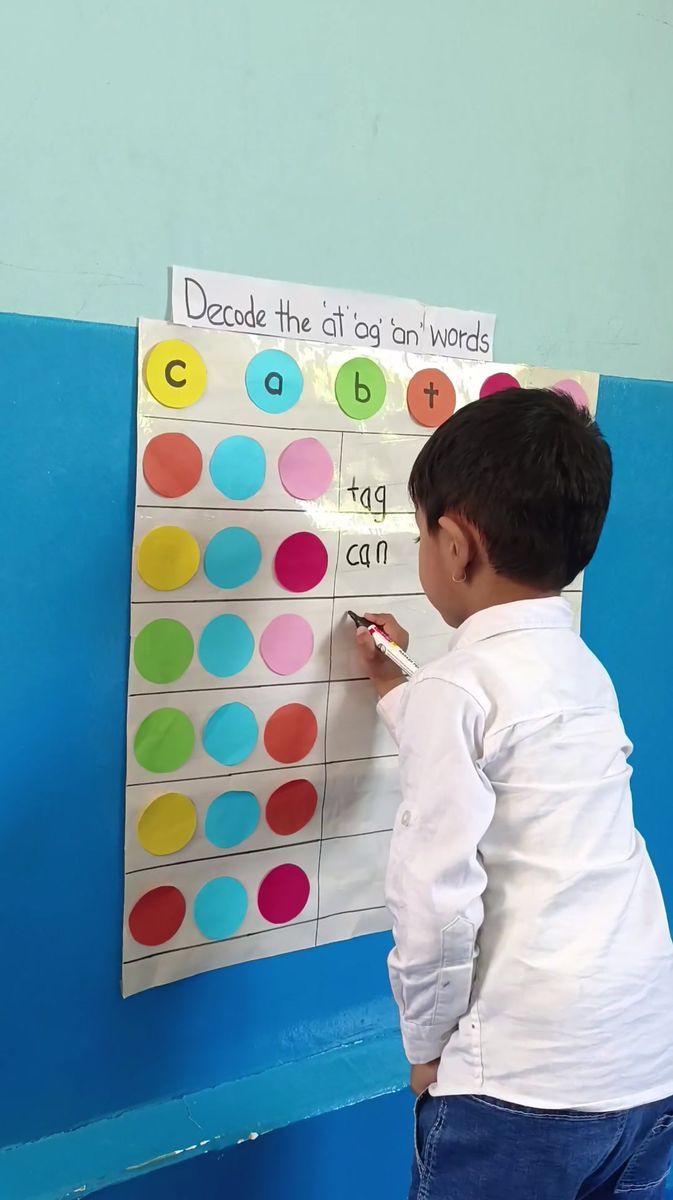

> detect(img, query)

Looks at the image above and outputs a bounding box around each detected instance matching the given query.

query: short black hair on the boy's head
[409,388,612,592]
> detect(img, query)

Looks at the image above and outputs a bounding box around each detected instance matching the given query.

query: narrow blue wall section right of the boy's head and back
[582,379,673,892]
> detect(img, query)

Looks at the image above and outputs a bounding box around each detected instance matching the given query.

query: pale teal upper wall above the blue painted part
[0,0,673,378]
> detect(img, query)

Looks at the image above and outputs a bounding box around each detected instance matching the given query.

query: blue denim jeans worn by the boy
[409,1093,673,1200]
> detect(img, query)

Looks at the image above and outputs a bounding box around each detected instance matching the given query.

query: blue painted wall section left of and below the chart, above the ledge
[0,317,395,1146]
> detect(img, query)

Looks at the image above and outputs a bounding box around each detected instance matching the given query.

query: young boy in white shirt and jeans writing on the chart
[357,389,673,1200]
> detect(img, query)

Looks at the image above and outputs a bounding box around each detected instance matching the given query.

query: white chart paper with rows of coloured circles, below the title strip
[124,322,597,995]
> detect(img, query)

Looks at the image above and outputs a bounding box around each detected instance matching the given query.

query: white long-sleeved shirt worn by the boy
[379,599,673,1111]
